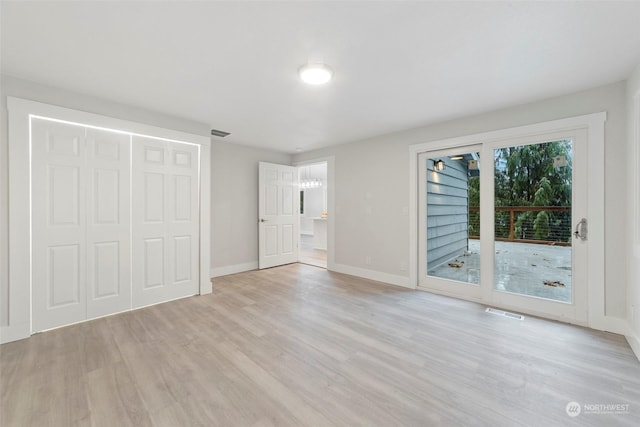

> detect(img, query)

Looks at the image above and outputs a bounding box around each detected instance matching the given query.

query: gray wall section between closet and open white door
[211,141,291,278]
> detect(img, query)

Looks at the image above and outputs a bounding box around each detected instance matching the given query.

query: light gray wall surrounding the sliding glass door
[294,82,627,318]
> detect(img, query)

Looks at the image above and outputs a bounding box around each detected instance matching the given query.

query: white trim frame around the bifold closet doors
[0,96,212,343]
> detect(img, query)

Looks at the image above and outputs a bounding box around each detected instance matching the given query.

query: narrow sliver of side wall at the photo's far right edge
[626,65,640,359]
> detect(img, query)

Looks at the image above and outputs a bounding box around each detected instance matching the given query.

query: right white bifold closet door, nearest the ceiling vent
[132,136,199,308]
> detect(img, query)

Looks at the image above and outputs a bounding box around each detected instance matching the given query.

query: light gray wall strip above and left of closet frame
[0,75,210,326]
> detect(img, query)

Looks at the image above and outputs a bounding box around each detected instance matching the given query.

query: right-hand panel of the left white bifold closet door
[86,129,131,319]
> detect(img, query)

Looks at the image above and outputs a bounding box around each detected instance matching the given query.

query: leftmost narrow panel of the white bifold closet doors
[31,119,87,332]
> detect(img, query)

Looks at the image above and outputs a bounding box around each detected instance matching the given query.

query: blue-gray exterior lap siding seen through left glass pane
[426,157,469,270]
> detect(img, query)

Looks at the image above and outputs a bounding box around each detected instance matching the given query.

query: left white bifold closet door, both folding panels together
[31,118,131,332]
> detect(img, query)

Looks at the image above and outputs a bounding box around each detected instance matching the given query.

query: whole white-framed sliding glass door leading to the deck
[411,114,604,328]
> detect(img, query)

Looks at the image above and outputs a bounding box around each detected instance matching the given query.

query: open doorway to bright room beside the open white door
[298,162,328,268]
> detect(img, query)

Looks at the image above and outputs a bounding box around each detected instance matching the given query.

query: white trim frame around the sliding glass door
[409,112,608,331]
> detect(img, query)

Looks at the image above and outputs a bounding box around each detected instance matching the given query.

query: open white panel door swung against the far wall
[258,162,300,269]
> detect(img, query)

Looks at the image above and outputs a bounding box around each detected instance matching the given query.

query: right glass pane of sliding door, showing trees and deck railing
[493,139,573,303]
